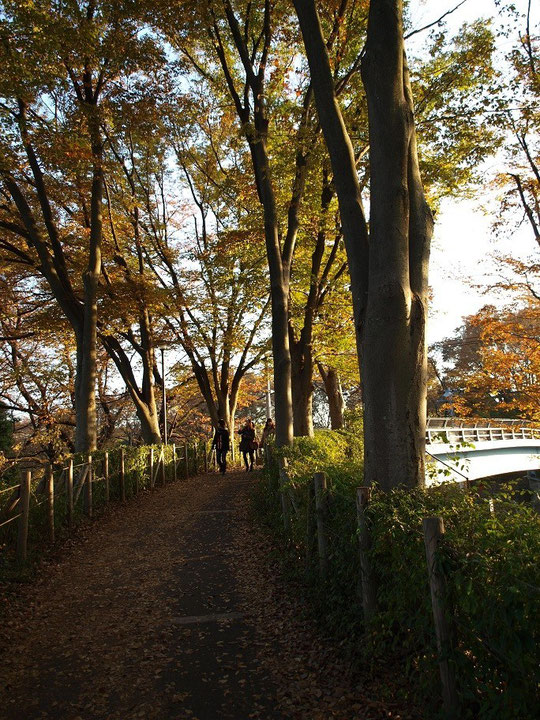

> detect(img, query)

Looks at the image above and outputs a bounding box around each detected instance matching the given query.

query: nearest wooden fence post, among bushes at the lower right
[422,517,459,718]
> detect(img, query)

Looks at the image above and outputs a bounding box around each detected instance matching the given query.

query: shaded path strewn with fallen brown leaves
[0,473,414,720]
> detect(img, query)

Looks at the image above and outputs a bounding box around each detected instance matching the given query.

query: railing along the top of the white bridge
[426,417,540,445]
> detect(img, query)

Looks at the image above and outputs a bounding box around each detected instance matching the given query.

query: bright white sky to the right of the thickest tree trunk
[410,0,540,343]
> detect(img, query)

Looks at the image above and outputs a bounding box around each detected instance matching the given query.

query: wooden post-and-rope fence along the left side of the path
[0,440,215,576]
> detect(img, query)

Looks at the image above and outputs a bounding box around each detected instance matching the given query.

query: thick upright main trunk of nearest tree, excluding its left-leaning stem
[362,0,433,488]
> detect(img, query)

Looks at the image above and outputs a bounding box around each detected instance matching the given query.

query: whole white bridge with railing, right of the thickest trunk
[426,418,540,487]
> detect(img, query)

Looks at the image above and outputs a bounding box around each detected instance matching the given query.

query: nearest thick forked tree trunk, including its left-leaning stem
[294,0,432,490]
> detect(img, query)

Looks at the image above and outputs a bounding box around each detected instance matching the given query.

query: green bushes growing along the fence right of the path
[261,432,540,720]
